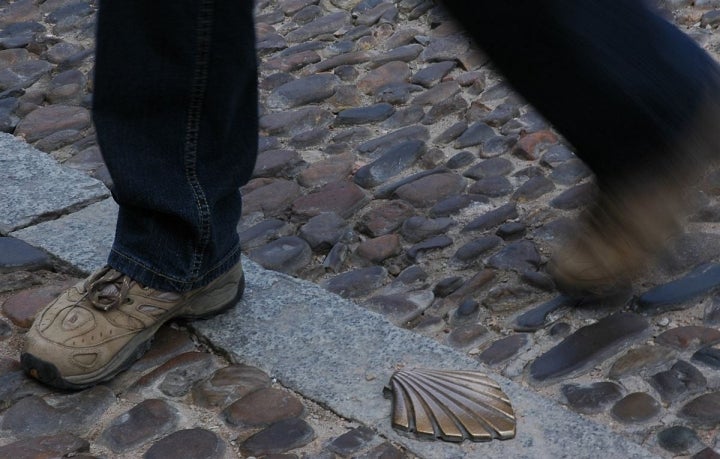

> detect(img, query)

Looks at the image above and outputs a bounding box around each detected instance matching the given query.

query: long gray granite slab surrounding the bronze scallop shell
[193,260,656,459]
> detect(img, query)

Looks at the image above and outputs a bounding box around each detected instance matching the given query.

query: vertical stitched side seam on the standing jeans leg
[185,0,214,278]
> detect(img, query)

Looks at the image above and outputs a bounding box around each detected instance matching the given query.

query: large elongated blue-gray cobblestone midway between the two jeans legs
[354,140,425,188]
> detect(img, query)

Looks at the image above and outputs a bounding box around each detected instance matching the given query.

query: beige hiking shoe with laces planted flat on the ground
[21,262,245,389]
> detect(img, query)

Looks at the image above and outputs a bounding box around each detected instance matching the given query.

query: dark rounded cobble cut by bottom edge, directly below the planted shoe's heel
[143,428,226,459]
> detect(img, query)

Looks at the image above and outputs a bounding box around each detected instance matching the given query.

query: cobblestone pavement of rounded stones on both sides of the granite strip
[0,0,720,458]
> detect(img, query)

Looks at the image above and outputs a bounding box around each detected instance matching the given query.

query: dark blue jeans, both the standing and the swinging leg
[94,0,719,291]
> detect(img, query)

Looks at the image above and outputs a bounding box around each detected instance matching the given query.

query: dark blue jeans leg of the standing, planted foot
[93,0,258,292]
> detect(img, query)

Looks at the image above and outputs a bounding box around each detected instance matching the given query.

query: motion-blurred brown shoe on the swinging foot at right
[548,178,687,296]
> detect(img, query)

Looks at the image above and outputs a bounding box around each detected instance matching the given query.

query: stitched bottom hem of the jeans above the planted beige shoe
[107,245,242,293]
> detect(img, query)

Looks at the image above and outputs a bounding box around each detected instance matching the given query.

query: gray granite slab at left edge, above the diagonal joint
[0,132,109,233]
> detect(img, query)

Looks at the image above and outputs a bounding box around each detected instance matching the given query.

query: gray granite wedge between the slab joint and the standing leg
[10,199,118,273]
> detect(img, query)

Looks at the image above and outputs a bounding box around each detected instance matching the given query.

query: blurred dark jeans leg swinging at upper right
[444,0,720,187]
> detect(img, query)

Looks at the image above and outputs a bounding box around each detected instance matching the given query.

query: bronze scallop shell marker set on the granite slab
[390,369,516,442]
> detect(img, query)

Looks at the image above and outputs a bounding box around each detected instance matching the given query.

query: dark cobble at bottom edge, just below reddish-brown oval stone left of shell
[240,419,315,456]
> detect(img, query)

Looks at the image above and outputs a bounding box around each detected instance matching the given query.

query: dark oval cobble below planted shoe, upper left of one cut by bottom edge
[101,399,179,453]
